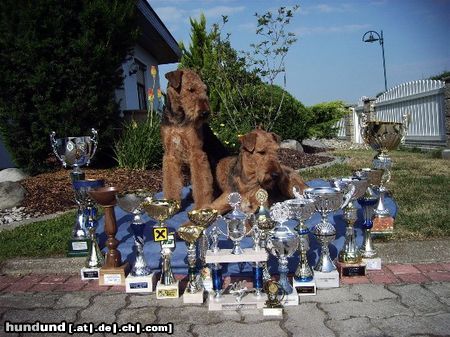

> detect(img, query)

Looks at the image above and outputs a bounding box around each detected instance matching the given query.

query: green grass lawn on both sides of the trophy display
[0,146,450,261]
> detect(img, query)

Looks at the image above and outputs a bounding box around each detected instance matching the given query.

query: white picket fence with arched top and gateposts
[338,80,447,146]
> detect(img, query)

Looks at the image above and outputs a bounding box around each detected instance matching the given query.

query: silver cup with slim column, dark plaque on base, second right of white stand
[285,193,316,295]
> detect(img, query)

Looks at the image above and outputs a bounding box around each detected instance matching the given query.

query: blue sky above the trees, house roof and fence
[148,0,450,106]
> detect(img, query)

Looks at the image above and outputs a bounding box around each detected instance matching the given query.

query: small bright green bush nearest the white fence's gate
[308,101,348,138]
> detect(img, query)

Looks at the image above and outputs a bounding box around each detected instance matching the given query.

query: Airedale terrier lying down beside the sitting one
[211,129,307,214]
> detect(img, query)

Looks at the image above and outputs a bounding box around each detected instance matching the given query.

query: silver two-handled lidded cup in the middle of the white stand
[224,192,248,255]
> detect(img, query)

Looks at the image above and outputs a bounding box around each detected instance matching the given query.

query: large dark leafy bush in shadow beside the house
[0,0,137,173]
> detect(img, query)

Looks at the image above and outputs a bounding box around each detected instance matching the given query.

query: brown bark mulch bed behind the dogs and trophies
[22,149,332,214]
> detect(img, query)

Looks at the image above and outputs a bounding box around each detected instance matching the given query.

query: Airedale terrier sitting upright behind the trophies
[161,69,228,209]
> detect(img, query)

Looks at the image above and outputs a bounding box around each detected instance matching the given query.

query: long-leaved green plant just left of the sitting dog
[114,113,163,170]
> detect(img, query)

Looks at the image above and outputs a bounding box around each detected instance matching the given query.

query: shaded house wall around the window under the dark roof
[116,45,163,117]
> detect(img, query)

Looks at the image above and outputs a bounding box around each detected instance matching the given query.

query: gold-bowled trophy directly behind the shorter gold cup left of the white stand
[188,208,219,291]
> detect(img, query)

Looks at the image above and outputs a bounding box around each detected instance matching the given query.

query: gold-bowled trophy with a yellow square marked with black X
[142,199,180,299]
